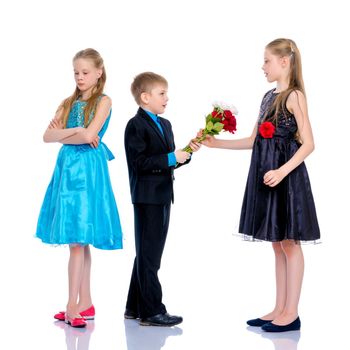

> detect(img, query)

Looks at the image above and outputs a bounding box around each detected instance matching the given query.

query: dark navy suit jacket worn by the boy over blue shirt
[124,108,187,204]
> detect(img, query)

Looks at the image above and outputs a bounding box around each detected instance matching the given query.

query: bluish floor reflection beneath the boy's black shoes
[124,320,182,350]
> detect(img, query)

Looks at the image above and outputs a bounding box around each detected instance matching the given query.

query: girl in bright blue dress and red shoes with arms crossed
[36,49,122,327]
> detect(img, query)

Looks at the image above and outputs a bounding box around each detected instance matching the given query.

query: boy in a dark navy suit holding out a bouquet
[124,72,200,327]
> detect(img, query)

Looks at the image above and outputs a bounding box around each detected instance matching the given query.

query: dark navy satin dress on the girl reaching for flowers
[239,89,320,242]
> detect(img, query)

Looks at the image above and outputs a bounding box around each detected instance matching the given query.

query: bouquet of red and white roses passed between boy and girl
[183,102,238,153]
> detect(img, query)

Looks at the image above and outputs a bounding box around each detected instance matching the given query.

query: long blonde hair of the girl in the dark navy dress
[265,38,305,122]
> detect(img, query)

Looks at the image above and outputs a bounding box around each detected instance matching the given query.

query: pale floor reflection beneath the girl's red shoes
[54,321,95,350]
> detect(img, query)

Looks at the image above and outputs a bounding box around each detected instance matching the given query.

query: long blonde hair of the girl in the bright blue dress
[59,48,107,127]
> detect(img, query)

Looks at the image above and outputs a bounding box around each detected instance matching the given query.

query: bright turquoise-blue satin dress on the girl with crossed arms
[36,100,122,250]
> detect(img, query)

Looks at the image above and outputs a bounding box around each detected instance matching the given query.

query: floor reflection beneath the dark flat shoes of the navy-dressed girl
[247,326,300,350]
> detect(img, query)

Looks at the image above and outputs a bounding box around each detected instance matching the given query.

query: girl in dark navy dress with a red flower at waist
[203,39,320,332]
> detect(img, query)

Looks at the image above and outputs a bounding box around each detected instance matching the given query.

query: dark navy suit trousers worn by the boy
[126,202,171,318]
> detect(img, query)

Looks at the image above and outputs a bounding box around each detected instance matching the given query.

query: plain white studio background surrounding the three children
[0,0,350,350]
